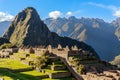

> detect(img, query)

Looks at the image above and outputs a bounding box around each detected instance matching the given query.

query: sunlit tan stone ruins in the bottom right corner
[83,70,120,80]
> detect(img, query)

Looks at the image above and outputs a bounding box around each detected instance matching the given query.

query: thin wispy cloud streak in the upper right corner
[88,2,120,17]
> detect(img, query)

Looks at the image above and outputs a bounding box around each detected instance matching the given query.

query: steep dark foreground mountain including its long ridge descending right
[3,7,97,56]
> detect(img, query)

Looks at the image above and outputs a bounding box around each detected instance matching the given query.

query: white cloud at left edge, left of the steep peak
[0,12,14,22]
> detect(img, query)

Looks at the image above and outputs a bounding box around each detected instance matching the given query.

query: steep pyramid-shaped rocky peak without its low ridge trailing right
[3,7,51,46]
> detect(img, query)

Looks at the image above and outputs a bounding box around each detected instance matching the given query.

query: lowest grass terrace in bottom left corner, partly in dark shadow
[0,68,43,80]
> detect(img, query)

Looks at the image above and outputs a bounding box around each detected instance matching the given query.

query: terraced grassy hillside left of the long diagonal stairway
[0,52,75,80]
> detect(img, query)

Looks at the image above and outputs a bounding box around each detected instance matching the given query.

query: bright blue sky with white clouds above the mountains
[0,0,120,22]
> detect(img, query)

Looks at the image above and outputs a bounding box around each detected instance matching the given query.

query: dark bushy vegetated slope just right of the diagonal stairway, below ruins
[69,52,99,74]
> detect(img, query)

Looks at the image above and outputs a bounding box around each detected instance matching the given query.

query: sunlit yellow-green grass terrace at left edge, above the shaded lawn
[0,59,31,70]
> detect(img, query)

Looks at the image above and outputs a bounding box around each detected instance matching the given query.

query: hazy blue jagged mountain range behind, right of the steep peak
[44,16,120,60]
